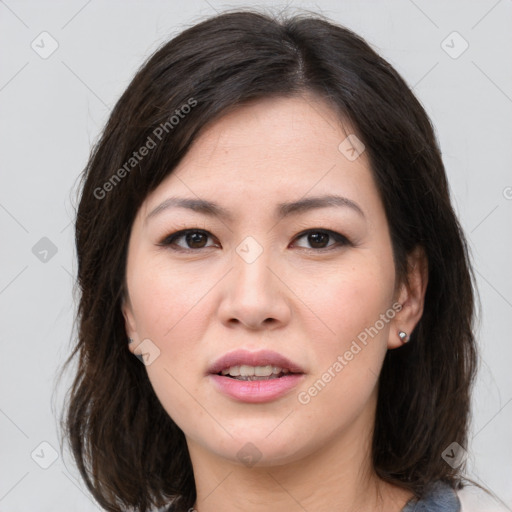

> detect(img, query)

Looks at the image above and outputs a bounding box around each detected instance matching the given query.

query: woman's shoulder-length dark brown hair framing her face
[63,11,476,512]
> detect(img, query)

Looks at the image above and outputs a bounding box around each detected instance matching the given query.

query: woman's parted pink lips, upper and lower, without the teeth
[208,350,304,403]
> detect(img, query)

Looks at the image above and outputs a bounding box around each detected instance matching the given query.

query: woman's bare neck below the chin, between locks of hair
[187,400,412,512]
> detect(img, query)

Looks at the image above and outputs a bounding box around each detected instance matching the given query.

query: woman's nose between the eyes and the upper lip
[219,241,291,330]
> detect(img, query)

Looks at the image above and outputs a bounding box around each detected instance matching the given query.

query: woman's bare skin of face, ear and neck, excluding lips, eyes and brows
[123,95,427,512]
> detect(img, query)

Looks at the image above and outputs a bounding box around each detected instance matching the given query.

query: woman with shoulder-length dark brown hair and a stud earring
[61,8,476,512]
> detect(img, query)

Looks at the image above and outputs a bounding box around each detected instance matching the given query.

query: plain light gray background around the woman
[0,0,512,512]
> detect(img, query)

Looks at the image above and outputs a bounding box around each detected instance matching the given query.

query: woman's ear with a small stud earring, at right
[388,245,428,349]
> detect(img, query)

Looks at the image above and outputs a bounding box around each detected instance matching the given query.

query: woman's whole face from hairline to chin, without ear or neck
[123,96,412,465]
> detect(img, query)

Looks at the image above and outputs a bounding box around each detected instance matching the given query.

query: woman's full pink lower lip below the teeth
[210,373,304,404]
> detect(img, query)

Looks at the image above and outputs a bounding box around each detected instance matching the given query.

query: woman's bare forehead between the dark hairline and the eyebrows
[140,96,378,222]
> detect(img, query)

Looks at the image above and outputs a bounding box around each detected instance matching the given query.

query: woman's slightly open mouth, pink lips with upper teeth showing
[208,350,305,403]
